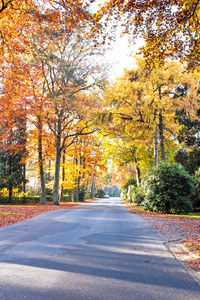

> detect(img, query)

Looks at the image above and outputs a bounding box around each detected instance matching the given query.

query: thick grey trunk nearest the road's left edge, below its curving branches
[53,120,61,205]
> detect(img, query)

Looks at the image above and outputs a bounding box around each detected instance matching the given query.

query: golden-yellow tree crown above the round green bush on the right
[102,59,199,169]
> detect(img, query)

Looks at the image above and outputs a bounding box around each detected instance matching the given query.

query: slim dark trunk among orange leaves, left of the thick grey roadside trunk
[38,116,46,204]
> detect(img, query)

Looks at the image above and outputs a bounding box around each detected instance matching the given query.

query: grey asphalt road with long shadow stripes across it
[0,198,200,300]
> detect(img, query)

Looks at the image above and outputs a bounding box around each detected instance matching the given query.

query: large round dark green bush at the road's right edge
[143,163,195,214]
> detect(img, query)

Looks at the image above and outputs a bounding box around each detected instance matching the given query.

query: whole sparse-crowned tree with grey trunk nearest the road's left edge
[30,22,105,204]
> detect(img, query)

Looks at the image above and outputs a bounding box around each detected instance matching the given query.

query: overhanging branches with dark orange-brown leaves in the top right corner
[94,0,200,69]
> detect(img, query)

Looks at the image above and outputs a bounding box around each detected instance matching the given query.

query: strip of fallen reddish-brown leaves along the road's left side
[0,202,79,227]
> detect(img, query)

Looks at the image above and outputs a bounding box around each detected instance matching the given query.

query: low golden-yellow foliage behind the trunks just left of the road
[60,133,102,201]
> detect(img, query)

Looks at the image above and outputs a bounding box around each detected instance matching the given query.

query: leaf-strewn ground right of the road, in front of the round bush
[124,203,200,275]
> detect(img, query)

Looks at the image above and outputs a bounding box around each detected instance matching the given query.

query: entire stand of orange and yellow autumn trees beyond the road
[0,0,200,217]
